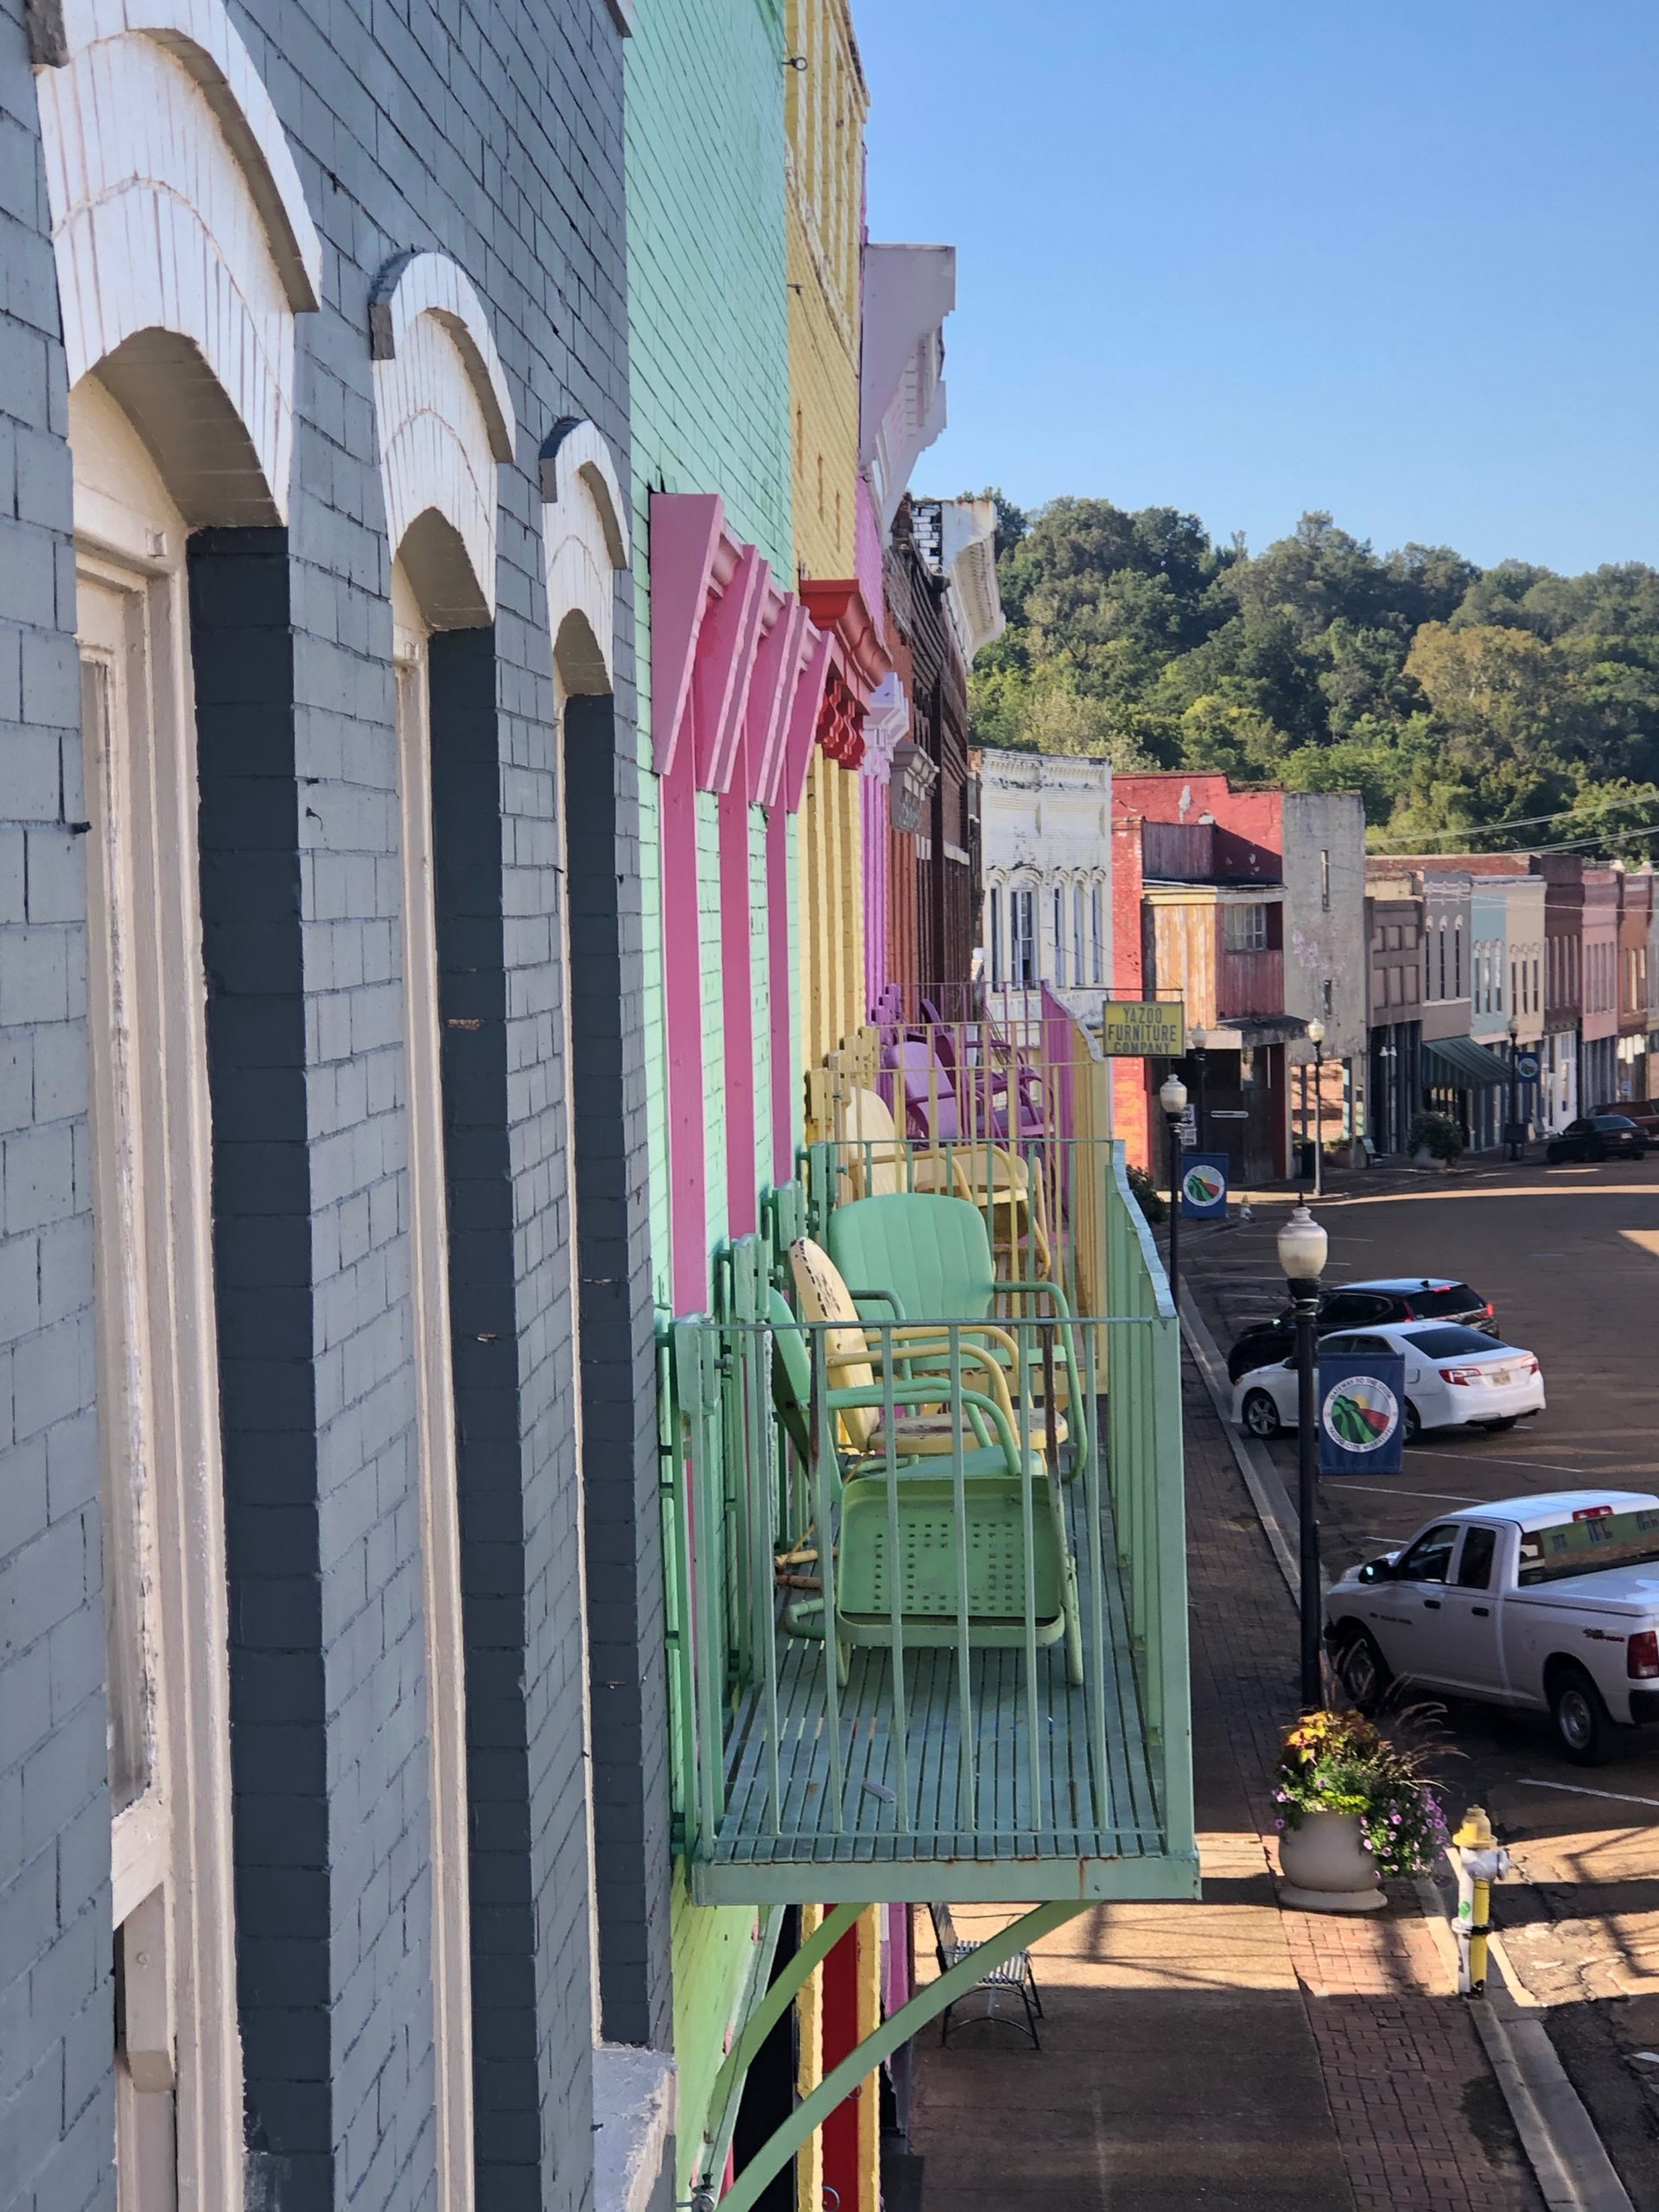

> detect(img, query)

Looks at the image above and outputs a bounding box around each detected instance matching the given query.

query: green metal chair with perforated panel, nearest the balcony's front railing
[770,1282,1084,1683]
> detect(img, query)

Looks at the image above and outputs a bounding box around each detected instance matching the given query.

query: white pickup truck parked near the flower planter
[1325,1491,1659,1765]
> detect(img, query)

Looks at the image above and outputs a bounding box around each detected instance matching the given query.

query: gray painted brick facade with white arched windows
[0,0,668,2212]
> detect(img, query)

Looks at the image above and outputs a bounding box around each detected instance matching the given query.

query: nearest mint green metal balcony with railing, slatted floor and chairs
[664,1139,1197,1903]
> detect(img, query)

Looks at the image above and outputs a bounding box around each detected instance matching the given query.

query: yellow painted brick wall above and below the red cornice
[785,0,869,1066]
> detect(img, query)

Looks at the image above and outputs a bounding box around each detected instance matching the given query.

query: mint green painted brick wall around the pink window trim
[626,0,794,2196]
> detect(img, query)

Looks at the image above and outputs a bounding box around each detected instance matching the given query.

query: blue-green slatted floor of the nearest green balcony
[692,1484,1197,1904]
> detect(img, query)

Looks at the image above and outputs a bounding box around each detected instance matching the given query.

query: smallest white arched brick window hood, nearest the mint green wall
[542,420,628,692]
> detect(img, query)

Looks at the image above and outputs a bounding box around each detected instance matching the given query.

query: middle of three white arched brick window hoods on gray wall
[370,254,515,628]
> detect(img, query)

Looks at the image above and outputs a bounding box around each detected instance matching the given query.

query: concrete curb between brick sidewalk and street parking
[1181,1292,1635,2212]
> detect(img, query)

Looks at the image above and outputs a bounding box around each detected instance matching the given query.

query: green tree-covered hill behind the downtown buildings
[973,493,1659,861]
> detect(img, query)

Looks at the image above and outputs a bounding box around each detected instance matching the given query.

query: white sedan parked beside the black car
[1232,1320,1544,1445]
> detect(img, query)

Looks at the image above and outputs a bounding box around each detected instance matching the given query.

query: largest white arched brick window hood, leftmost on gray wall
[35,0,323,522]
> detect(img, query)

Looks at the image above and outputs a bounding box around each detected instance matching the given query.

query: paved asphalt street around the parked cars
[1185,1161,1659,2208]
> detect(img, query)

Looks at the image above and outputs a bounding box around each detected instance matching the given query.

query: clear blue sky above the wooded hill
[854,0,1659,570]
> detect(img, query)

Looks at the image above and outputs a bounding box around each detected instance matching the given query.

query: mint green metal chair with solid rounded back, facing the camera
[830,1192,1089,1476]
